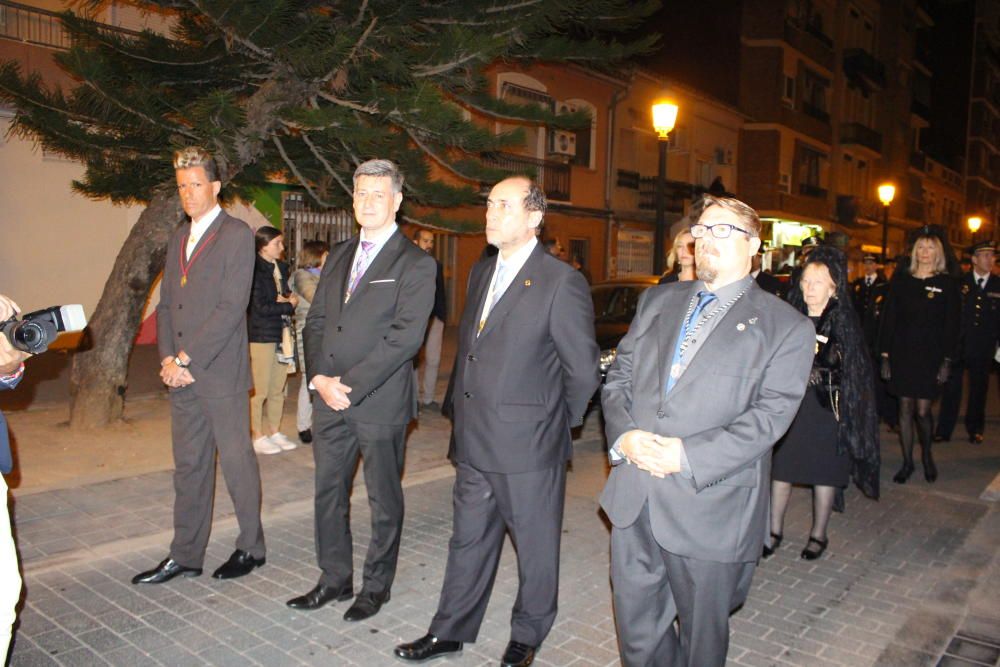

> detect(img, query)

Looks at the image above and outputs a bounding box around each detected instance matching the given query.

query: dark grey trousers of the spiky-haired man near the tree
[170,389,264,567]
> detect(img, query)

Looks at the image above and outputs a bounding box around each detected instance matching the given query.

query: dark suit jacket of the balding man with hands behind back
[444,244,600,473]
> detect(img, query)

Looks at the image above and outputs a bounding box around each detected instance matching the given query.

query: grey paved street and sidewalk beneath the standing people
[1,384,1000,667]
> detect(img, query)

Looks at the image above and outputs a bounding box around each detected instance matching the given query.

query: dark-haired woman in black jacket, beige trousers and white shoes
[247,225,298,454]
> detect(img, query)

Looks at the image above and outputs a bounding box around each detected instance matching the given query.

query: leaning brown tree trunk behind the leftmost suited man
[69,192,182,429]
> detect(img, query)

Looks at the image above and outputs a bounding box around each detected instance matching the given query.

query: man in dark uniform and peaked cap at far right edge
[934,241,1000,445]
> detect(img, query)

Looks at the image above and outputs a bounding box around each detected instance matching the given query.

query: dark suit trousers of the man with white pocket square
[313,402,406,593]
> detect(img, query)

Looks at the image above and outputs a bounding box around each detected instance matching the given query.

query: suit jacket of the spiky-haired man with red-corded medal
[156,211,254,398]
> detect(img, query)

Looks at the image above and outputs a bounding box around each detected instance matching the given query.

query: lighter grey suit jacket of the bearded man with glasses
[601,283,816,562]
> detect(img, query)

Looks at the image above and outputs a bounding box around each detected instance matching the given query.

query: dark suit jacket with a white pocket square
[302,230,437,424]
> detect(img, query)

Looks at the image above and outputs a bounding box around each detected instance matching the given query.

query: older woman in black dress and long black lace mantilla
[764,246,879,560]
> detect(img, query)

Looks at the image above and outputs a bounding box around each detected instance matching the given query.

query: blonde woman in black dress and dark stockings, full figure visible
[879,228,961,484]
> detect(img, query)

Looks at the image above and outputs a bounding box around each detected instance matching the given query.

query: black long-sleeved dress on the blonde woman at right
[879,273,961,399]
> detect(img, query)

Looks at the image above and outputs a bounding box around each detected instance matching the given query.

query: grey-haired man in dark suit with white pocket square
[288,160,436,621]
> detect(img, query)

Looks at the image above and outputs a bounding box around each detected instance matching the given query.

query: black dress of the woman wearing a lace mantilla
[771,317,851,487]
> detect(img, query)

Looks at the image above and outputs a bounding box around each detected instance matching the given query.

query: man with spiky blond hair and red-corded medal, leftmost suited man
[132,148,264,584]
